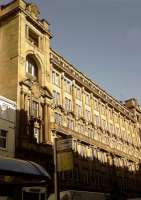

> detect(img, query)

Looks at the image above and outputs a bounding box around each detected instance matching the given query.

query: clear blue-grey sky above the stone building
[1,0,141,103]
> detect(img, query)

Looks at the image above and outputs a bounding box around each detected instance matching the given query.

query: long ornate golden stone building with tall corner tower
[0,0,141,196]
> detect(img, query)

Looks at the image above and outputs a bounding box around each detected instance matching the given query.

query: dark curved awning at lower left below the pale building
[0,156,51,180]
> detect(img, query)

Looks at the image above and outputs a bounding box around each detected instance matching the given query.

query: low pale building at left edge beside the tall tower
[0,96,16,157]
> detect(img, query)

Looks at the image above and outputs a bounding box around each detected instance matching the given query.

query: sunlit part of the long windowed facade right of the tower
[51,51,141,170]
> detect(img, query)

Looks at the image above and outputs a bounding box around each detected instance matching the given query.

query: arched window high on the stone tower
[25,55,38,78]
